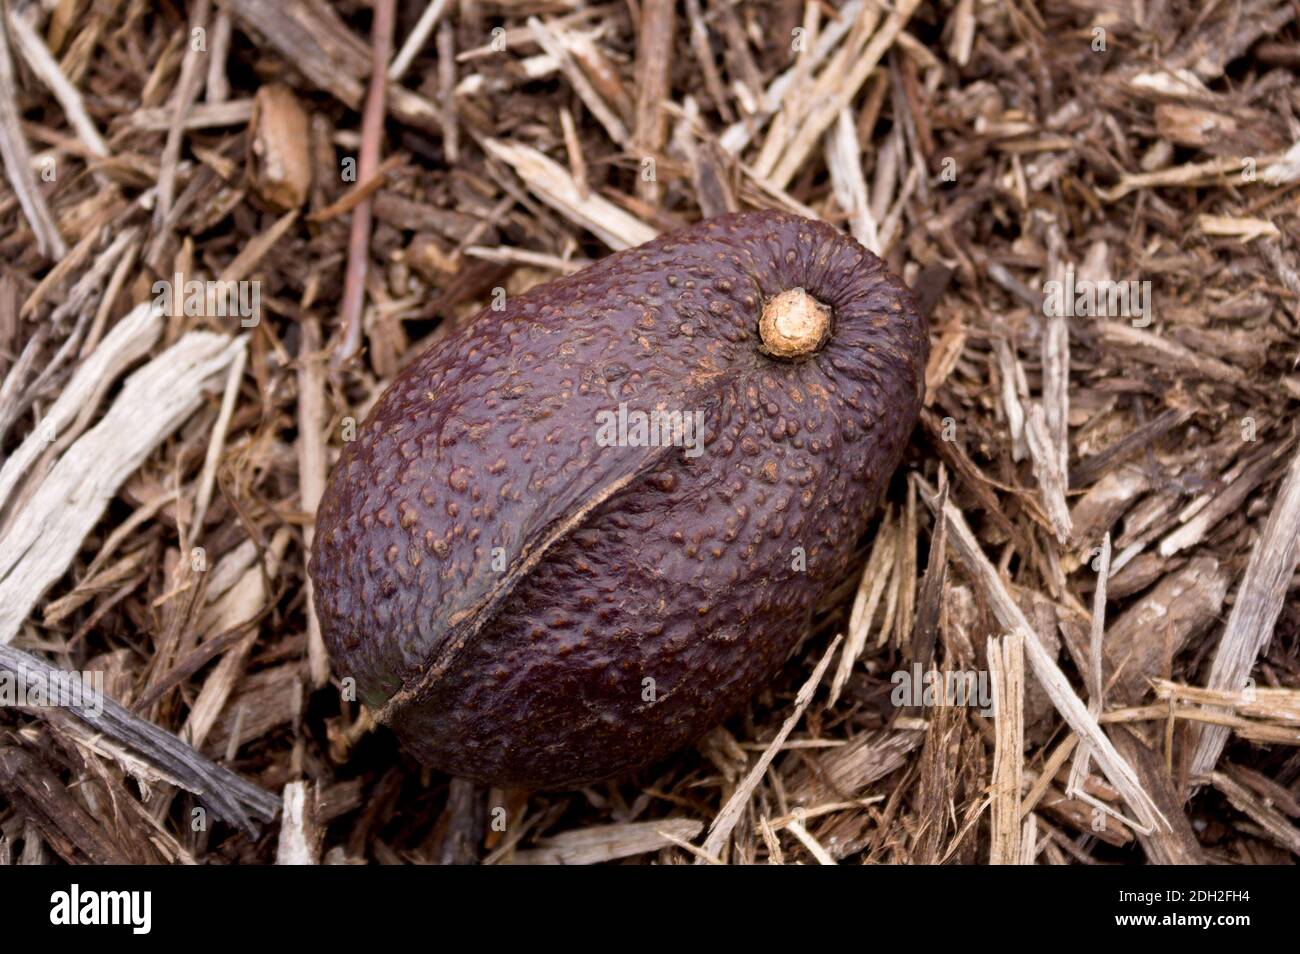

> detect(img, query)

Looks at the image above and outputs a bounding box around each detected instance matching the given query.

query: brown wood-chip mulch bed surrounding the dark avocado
[0,0,1300,864]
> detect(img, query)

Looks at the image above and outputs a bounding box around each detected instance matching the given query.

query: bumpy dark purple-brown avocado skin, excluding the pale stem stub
[309,212,928,789]
